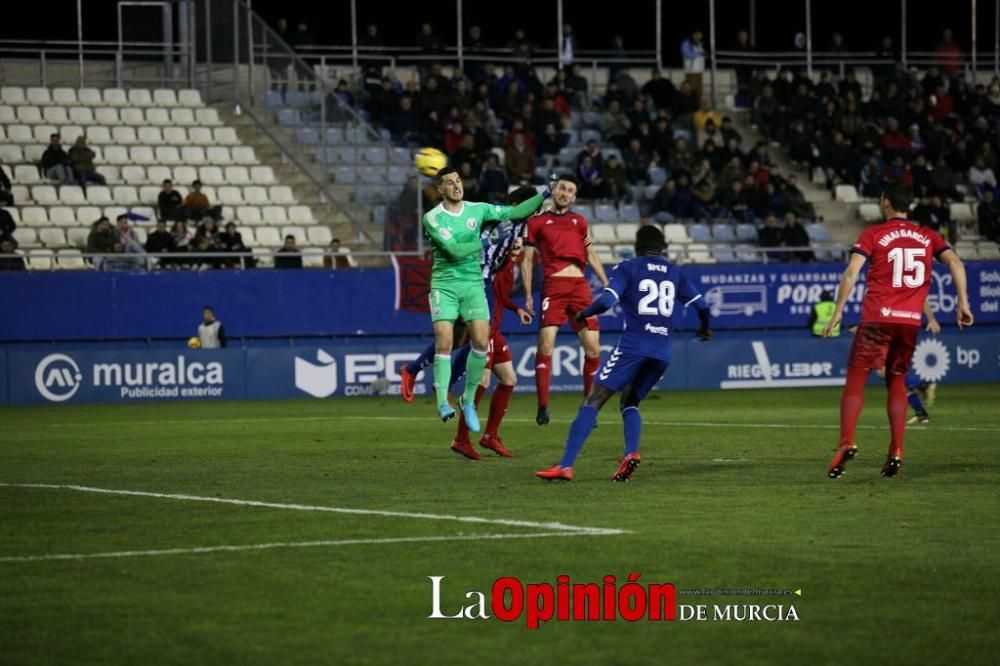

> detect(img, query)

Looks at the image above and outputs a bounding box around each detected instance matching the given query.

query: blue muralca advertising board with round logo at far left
[6,349,246,405]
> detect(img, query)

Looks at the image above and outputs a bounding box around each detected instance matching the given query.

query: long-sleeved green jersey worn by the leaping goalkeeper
[424,194,542,284]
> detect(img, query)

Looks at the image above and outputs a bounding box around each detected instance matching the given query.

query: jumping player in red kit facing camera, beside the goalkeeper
[522,176,608,425]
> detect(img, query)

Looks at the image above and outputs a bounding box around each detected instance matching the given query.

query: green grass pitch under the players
[0,385,1000,665]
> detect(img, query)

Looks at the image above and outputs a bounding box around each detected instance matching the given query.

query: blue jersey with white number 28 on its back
[605,257,701,361]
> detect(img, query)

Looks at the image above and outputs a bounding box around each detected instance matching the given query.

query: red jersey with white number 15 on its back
[851,217,951,326]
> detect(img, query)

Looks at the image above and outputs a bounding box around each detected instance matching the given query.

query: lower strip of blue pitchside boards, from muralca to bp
[0,329,1000,404]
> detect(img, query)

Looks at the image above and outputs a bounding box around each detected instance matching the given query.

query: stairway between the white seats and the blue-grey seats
[216,105,385,258]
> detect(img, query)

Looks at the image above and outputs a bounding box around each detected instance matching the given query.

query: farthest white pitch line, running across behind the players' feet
[35,414,1000,432]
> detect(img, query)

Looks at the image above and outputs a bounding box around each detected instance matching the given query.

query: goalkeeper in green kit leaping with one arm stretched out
[423,167,549,432]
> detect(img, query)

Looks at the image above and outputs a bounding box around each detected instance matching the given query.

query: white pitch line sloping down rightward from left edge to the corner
[0,482,626,535]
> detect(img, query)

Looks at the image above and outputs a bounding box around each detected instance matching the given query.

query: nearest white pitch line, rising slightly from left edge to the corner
[0,530,596,563]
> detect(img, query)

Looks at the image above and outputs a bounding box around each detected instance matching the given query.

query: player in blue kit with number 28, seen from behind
[536,225,712,481]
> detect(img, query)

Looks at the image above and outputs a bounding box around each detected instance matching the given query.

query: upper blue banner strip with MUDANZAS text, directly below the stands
[0,262,1000,342]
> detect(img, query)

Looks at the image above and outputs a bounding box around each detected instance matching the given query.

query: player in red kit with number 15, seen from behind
[824,183,973,479]
